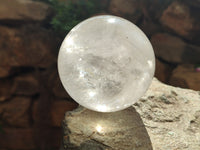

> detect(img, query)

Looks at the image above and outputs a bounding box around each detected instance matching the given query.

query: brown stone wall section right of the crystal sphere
[109,0,200,90]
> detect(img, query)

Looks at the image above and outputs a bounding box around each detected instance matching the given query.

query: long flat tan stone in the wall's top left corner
[0,0,51,22]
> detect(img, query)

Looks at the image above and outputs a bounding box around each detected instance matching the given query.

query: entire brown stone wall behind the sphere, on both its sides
[0,0,200,150]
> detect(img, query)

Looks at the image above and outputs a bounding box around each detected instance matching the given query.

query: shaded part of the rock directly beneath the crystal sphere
[63,107,152,150]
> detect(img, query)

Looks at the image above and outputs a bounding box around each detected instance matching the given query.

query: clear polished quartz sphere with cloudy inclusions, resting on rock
[58,15,155,112]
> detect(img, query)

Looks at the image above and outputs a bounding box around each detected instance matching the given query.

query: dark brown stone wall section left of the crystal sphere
[0,0,77,150]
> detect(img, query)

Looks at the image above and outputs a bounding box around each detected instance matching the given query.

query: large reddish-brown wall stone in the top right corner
[160,0,200,42]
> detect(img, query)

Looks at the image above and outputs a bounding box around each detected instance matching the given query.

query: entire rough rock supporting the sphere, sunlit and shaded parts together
[63,79,200,150]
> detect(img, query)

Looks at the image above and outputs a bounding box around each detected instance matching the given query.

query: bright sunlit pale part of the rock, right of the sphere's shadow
[134,79,200,150]
